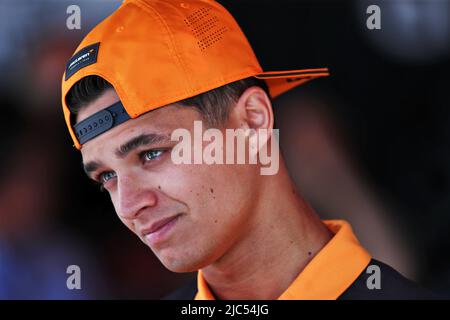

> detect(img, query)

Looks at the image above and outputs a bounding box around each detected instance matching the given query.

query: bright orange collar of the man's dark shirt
[195,220,371,300]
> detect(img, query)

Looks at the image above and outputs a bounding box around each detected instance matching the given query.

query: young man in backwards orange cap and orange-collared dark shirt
[62,0,427,299]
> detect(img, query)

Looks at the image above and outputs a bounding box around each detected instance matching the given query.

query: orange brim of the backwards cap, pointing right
[254,68,330,98]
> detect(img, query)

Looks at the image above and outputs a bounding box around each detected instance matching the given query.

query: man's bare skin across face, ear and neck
[77,87,331,299]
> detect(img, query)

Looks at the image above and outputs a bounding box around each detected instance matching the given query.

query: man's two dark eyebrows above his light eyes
[83,133,170,177]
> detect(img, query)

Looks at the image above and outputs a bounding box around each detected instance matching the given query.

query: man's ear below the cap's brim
[232,86,273,132]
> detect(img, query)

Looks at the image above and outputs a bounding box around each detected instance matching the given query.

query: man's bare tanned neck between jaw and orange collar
[202,163,332,300]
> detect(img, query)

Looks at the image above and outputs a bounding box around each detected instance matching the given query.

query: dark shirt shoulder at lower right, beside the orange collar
[339,259,439,300]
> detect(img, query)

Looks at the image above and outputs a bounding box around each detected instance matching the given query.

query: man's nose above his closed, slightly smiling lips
[115,175,157,220]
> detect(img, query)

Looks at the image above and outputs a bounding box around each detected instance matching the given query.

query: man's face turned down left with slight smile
[77,89,258,272]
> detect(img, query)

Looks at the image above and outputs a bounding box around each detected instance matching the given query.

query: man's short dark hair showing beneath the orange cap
[66,75,270,126]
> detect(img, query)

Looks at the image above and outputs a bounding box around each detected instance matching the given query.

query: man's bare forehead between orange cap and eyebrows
[77,89,200,163]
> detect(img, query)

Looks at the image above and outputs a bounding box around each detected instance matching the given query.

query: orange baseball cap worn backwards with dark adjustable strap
[62,0,329,149]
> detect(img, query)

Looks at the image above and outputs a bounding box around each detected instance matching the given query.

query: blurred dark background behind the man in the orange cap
[0,0,450,299]
